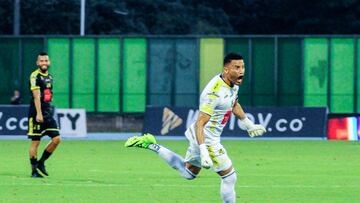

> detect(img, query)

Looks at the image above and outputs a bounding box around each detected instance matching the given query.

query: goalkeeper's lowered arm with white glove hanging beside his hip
[195,111,213,169]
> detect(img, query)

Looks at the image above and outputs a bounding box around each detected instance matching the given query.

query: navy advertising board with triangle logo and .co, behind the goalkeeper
[143,106,327,138]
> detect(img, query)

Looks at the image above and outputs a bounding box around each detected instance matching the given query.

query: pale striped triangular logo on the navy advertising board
[160,107,183,135]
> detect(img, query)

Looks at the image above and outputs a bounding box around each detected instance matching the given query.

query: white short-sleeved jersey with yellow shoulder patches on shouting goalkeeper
[185,75,239,144]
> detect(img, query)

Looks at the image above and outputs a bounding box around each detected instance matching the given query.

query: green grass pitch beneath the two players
[0,140,360,203]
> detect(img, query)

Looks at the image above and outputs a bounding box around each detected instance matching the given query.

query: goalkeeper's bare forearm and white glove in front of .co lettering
[233,102,266,137]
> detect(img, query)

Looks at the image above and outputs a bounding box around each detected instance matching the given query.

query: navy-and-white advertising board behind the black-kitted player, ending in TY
[0,105,87,137]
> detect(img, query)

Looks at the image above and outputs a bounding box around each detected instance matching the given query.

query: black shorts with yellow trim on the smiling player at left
[28,108,60,140]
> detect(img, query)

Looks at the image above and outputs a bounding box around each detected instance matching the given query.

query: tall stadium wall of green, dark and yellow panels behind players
[0,35,360,114]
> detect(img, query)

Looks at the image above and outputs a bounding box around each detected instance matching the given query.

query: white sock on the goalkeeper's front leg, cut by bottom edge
[220,169,237,203]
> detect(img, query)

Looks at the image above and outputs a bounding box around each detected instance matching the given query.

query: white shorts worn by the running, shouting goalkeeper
[185,137,232,172]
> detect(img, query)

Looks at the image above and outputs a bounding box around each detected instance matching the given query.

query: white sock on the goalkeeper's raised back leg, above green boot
[149,144,196,180]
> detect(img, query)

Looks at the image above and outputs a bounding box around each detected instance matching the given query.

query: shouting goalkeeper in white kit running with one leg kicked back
[125,53,266,202]
